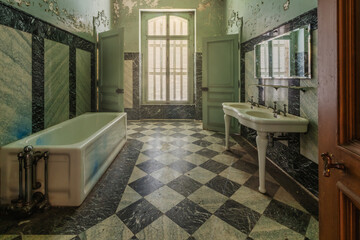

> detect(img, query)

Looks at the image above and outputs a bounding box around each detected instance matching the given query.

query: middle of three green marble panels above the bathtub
[44,39,69,128]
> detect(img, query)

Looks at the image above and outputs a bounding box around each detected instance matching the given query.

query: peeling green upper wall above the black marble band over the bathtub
[0,0,111,41]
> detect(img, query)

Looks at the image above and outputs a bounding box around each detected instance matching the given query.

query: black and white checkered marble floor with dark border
[0,121,318,240]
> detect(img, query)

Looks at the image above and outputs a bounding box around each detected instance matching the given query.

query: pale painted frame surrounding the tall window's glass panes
[139,9,196,105]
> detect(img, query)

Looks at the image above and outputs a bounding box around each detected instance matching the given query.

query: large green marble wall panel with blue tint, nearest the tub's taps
[0,25,32,146]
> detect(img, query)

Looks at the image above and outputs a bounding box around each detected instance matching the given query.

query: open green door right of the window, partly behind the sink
[202,35,239,132]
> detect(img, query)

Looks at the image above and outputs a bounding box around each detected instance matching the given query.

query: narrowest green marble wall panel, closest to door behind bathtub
[76,49,91,116]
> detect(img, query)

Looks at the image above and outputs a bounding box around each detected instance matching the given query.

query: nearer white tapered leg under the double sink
[256,131,269,193]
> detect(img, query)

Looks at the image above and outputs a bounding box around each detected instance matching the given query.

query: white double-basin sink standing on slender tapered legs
[222,103,309,193]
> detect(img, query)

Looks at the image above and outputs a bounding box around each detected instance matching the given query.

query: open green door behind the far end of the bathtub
[99,28,124,112]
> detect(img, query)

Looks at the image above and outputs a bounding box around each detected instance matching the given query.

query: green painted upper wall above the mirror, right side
[226,0,317,42]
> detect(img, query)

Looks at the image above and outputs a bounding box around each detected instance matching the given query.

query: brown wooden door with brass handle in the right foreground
[318,0,360,240]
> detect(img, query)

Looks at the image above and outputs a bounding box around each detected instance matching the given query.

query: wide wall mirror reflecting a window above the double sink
[254,25,311,79]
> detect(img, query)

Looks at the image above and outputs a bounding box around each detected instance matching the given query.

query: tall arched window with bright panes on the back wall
[141,12,194,104]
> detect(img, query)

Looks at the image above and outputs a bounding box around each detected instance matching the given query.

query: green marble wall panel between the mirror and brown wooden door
[300,30,319,163]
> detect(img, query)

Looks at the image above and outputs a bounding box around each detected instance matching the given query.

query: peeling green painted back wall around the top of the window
[111,0,226,52]
